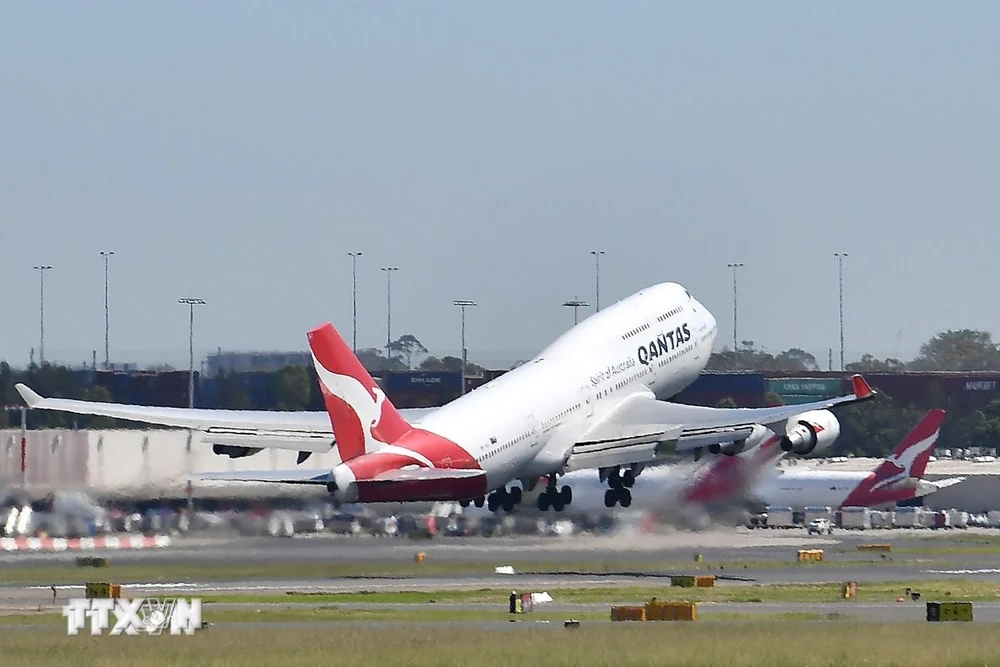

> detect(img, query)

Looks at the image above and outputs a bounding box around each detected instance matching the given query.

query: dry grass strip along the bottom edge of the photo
[0,620,1000,667]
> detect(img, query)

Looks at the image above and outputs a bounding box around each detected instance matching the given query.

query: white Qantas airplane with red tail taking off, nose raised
[17,282,875,512]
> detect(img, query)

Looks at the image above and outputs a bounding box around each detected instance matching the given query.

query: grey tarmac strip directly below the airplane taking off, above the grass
[0,528,1000,566]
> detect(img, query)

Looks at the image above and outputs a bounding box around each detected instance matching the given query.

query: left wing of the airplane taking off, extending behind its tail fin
[15,384,435,452]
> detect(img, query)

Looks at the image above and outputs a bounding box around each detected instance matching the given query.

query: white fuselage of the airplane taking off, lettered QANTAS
[410,283,716,489]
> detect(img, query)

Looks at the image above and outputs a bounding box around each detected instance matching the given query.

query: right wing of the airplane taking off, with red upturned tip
[567,375,875,470]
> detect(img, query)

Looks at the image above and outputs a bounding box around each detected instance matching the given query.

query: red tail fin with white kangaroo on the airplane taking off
[306,323,411,461]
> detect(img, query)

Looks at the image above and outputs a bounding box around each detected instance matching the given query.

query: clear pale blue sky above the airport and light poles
[0,2,1000,364]
